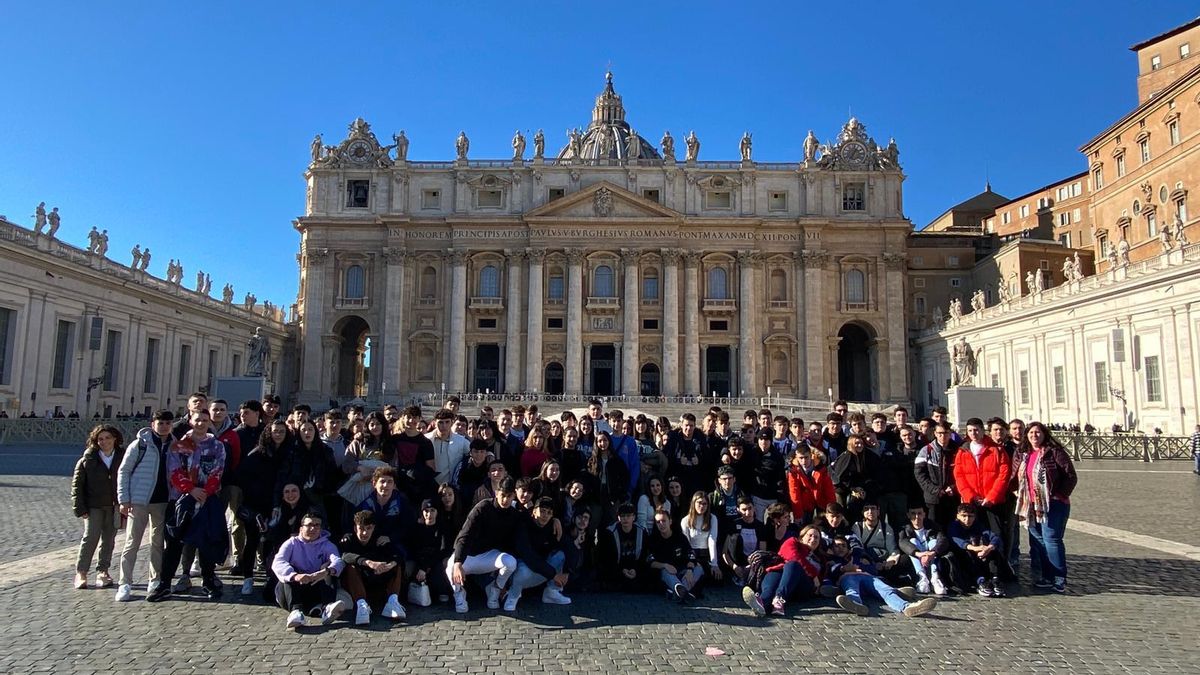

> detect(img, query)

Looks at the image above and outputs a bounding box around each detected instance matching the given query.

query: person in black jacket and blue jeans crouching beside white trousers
[504,497,571,611]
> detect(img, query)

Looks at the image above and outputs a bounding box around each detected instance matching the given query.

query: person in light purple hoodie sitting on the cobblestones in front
[271,512,348,628]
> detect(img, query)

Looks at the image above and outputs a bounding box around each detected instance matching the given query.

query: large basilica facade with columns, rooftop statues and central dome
[295,76,912,401]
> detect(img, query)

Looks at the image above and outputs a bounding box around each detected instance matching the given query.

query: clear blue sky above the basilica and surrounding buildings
[0,0,1196,306]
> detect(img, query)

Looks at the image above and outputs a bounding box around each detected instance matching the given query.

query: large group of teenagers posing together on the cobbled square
[71,393,1076,628]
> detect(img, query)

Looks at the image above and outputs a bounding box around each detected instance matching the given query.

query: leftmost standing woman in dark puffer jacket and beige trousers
[71,424,125,589]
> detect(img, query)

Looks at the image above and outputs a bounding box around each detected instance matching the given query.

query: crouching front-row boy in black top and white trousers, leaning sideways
[446,477,521,614]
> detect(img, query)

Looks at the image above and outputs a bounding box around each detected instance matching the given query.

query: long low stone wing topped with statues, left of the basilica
[0,219,294,417]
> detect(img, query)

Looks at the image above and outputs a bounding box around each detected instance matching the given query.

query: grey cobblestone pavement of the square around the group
[0,444,1200,674]
